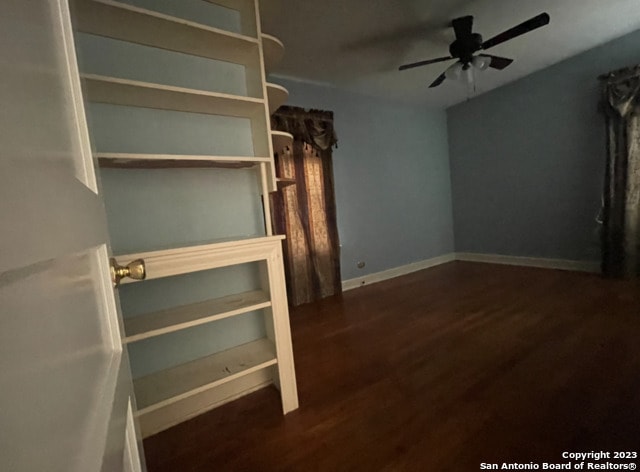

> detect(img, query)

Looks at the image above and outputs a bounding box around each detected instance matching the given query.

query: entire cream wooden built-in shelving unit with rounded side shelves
[72,0,298,436]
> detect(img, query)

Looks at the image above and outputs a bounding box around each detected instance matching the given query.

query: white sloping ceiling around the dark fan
[261,0,640,107]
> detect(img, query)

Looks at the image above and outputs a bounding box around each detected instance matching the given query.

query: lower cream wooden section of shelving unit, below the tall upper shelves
[111,236,298,436]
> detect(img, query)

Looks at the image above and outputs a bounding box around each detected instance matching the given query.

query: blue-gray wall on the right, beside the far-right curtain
[447,31,640,261]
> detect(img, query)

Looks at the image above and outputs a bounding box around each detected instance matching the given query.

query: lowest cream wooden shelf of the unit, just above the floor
[133,338,277,415]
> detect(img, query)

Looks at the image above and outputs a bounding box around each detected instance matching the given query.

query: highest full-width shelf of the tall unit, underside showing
[72,0,258,64]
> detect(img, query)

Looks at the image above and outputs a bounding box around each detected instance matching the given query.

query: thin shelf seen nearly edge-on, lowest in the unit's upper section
[94,152,271,169]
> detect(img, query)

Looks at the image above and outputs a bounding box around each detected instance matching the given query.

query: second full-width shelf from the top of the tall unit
[81,74,264,118]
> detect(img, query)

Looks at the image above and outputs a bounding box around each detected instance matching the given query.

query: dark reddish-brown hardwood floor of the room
[144,262,640,472]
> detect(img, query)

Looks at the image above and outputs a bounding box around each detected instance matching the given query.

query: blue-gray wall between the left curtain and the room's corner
[270,77,453,280]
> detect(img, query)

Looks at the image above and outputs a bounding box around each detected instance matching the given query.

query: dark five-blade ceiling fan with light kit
[399,13,551,87]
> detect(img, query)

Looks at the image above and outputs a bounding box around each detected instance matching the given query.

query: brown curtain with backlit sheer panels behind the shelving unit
[271,107,342,306]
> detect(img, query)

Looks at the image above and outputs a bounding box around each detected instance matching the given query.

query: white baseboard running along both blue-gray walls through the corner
[342,252,600,292]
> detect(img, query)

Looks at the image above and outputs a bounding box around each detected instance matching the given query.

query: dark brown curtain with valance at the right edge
[600,62,640,278]
